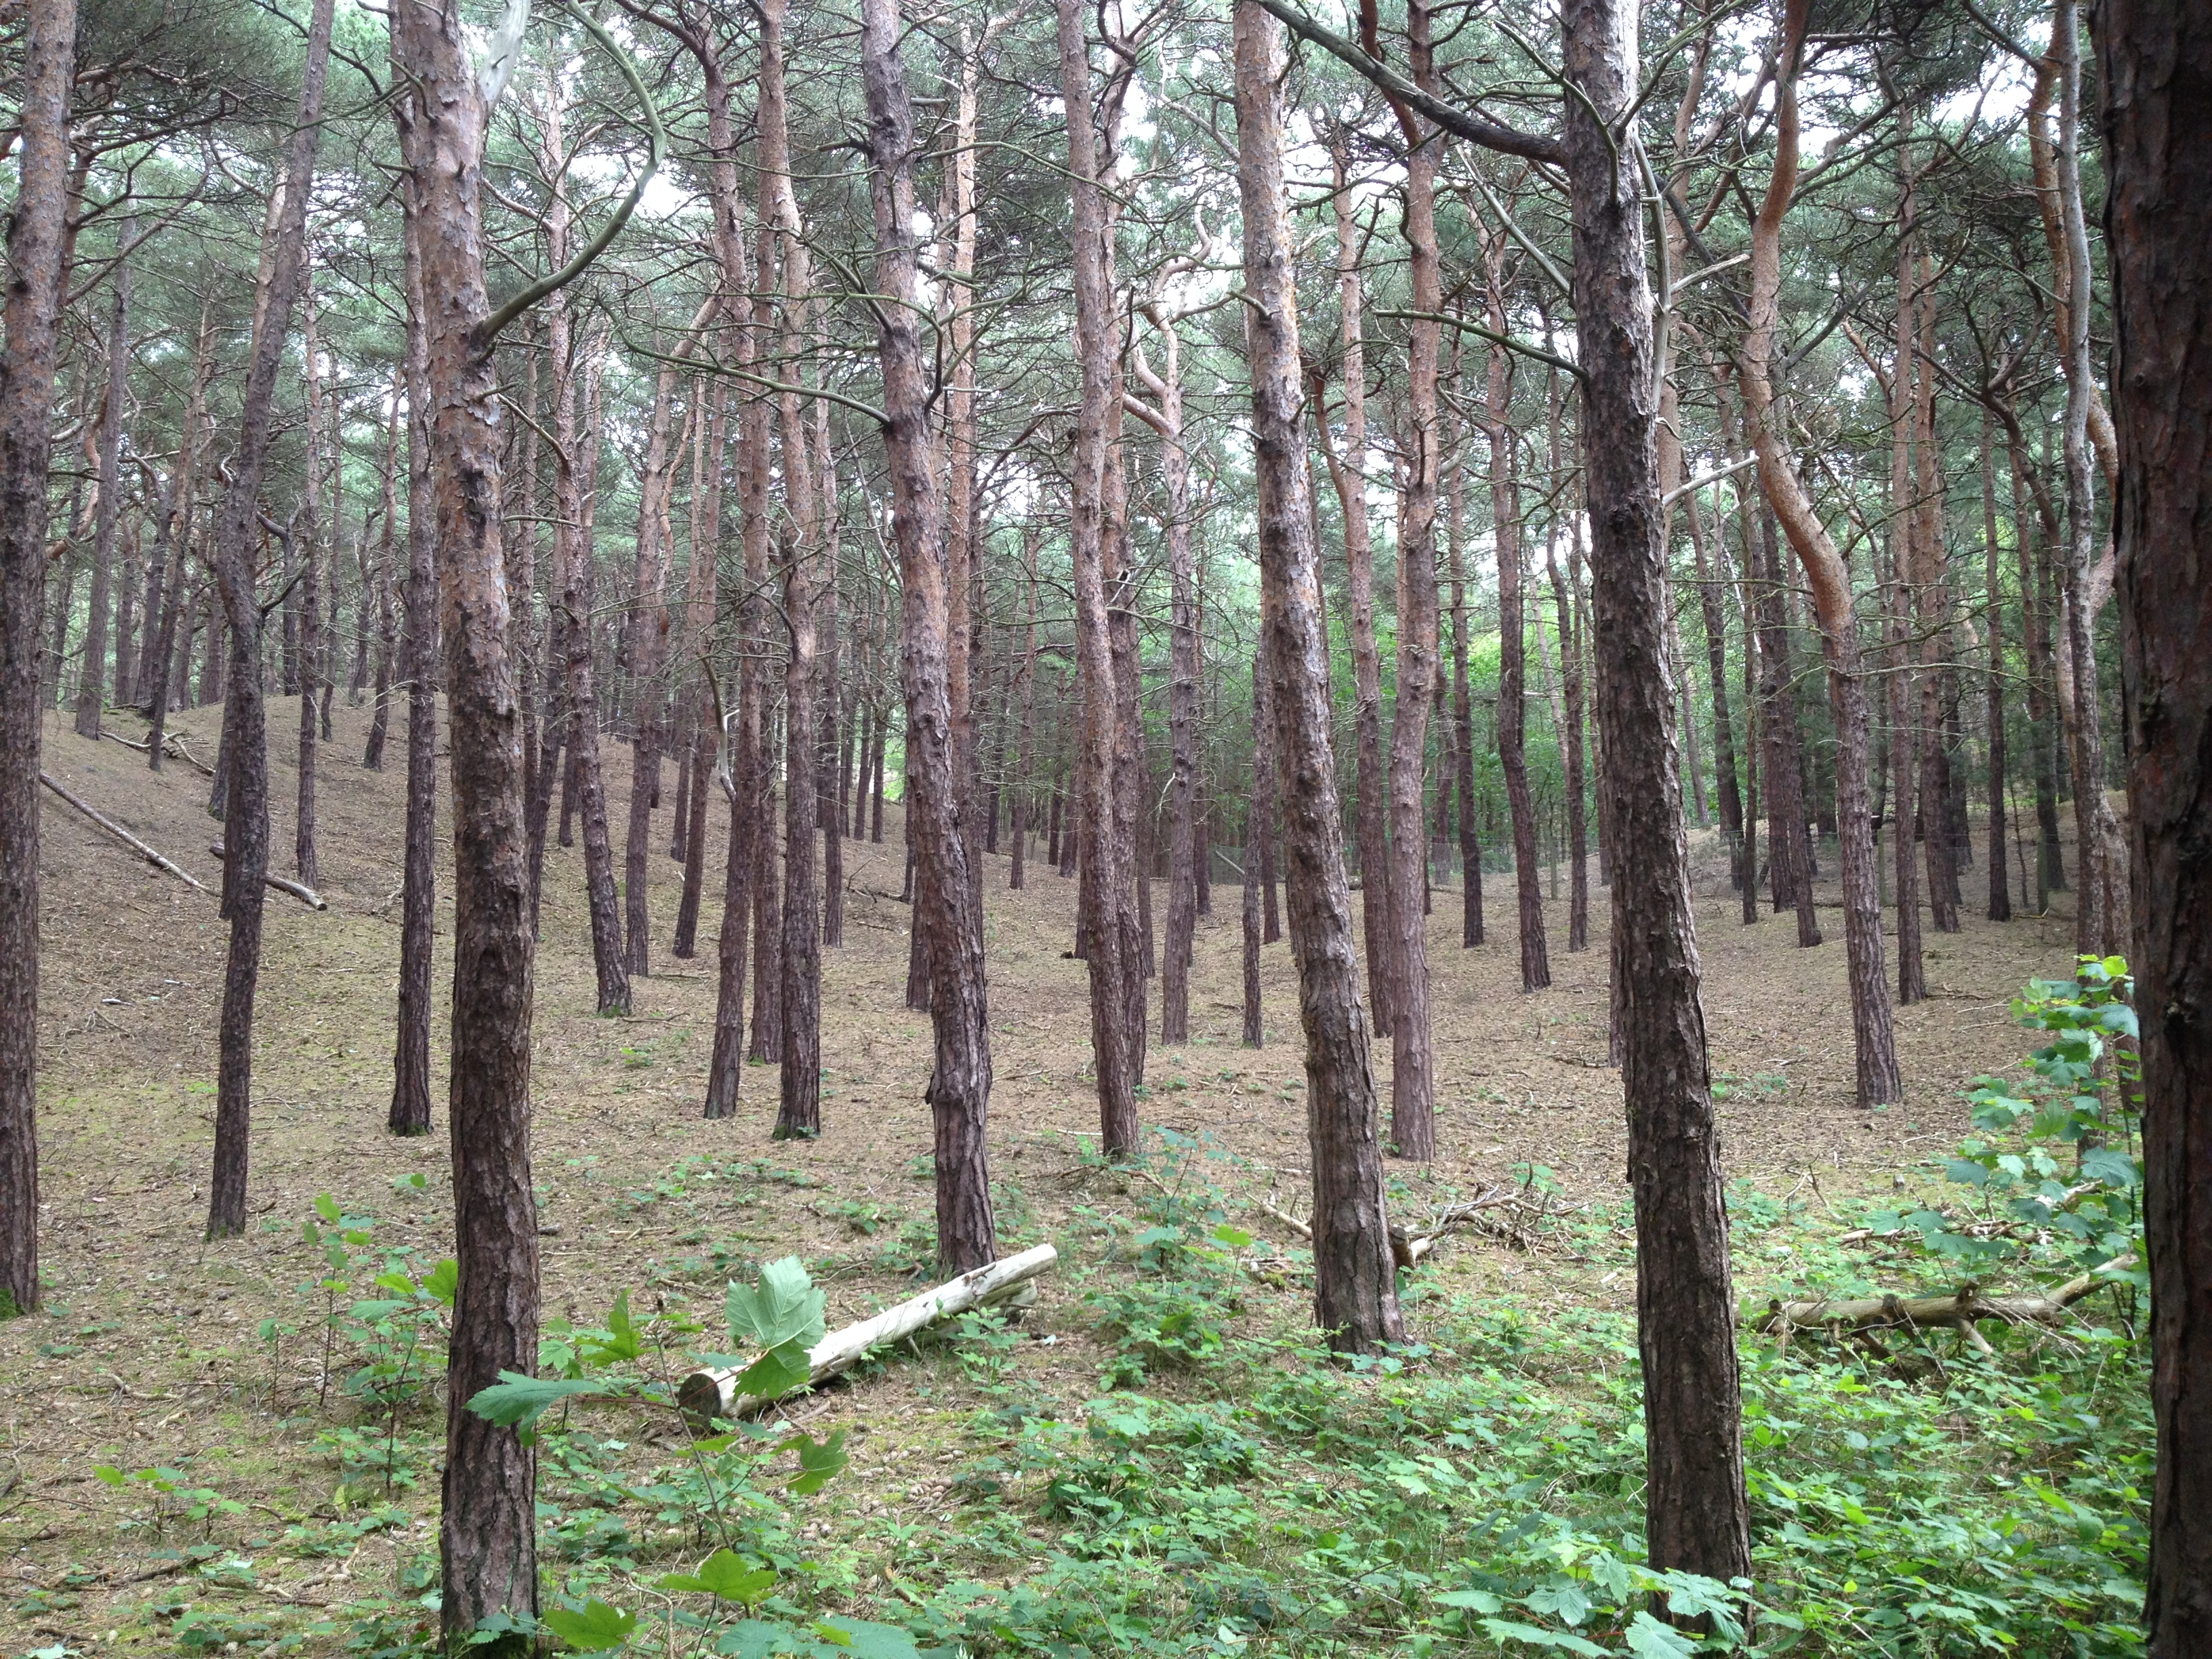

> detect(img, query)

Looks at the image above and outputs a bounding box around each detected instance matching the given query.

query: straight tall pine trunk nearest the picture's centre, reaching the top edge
[1061,0,1143,1159]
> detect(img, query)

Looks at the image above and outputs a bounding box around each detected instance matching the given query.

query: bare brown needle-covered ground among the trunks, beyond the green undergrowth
[0,697,2070,1652]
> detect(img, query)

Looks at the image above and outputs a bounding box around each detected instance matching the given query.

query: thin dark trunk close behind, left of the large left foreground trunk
[385,201,438,1134]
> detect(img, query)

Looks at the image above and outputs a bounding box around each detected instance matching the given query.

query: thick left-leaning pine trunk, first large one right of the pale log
[1234,0,1405,1354]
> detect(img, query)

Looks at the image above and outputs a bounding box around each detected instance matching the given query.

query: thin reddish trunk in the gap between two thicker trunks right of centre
[1314,128,1393,1038]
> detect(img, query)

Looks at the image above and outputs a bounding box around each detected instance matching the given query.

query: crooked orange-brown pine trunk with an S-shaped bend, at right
[1736,0,1904,1106]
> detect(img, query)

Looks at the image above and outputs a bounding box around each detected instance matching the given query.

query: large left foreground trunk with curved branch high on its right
[392,0,537,1659]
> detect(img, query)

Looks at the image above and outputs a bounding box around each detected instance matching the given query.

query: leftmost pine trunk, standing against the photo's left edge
[0,0,77,1314]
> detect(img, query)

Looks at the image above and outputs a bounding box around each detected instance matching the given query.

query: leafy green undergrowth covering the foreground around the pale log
[44,964,2152,1659]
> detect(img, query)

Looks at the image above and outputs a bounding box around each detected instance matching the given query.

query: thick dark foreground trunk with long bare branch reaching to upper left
[1564,0,1752,1584]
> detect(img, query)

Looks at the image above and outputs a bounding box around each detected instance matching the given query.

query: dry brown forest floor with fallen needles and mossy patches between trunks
[0,699,2123,1654]
